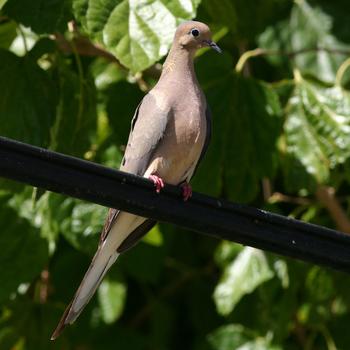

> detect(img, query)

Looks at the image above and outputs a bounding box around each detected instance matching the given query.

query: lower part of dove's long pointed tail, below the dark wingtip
[51,242,119,340]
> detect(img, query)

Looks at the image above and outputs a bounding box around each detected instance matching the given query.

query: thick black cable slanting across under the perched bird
[0,137,350,272]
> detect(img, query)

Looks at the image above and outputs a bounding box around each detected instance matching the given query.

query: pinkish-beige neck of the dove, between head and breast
[161,46,197,82]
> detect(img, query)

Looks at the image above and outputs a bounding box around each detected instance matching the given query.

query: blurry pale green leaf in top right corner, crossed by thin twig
[259,0,350,83]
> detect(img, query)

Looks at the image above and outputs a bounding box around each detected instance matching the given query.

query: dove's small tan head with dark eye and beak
[175,21,221,53]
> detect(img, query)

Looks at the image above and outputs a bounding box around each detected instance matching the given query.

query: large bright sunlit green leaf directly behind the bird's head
[73,0,200,72]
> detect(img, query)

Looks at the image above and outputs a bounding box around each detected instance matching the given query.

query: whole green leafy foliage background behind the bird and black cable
[0,0,350,350]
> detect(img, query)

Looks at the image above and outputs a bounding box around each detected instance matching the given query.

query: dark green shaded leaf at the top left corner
[3,0,71,33]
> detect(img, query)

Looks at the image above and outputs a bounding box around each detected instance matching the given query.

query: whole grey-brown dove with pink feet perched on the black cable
[51,21,221,340]
